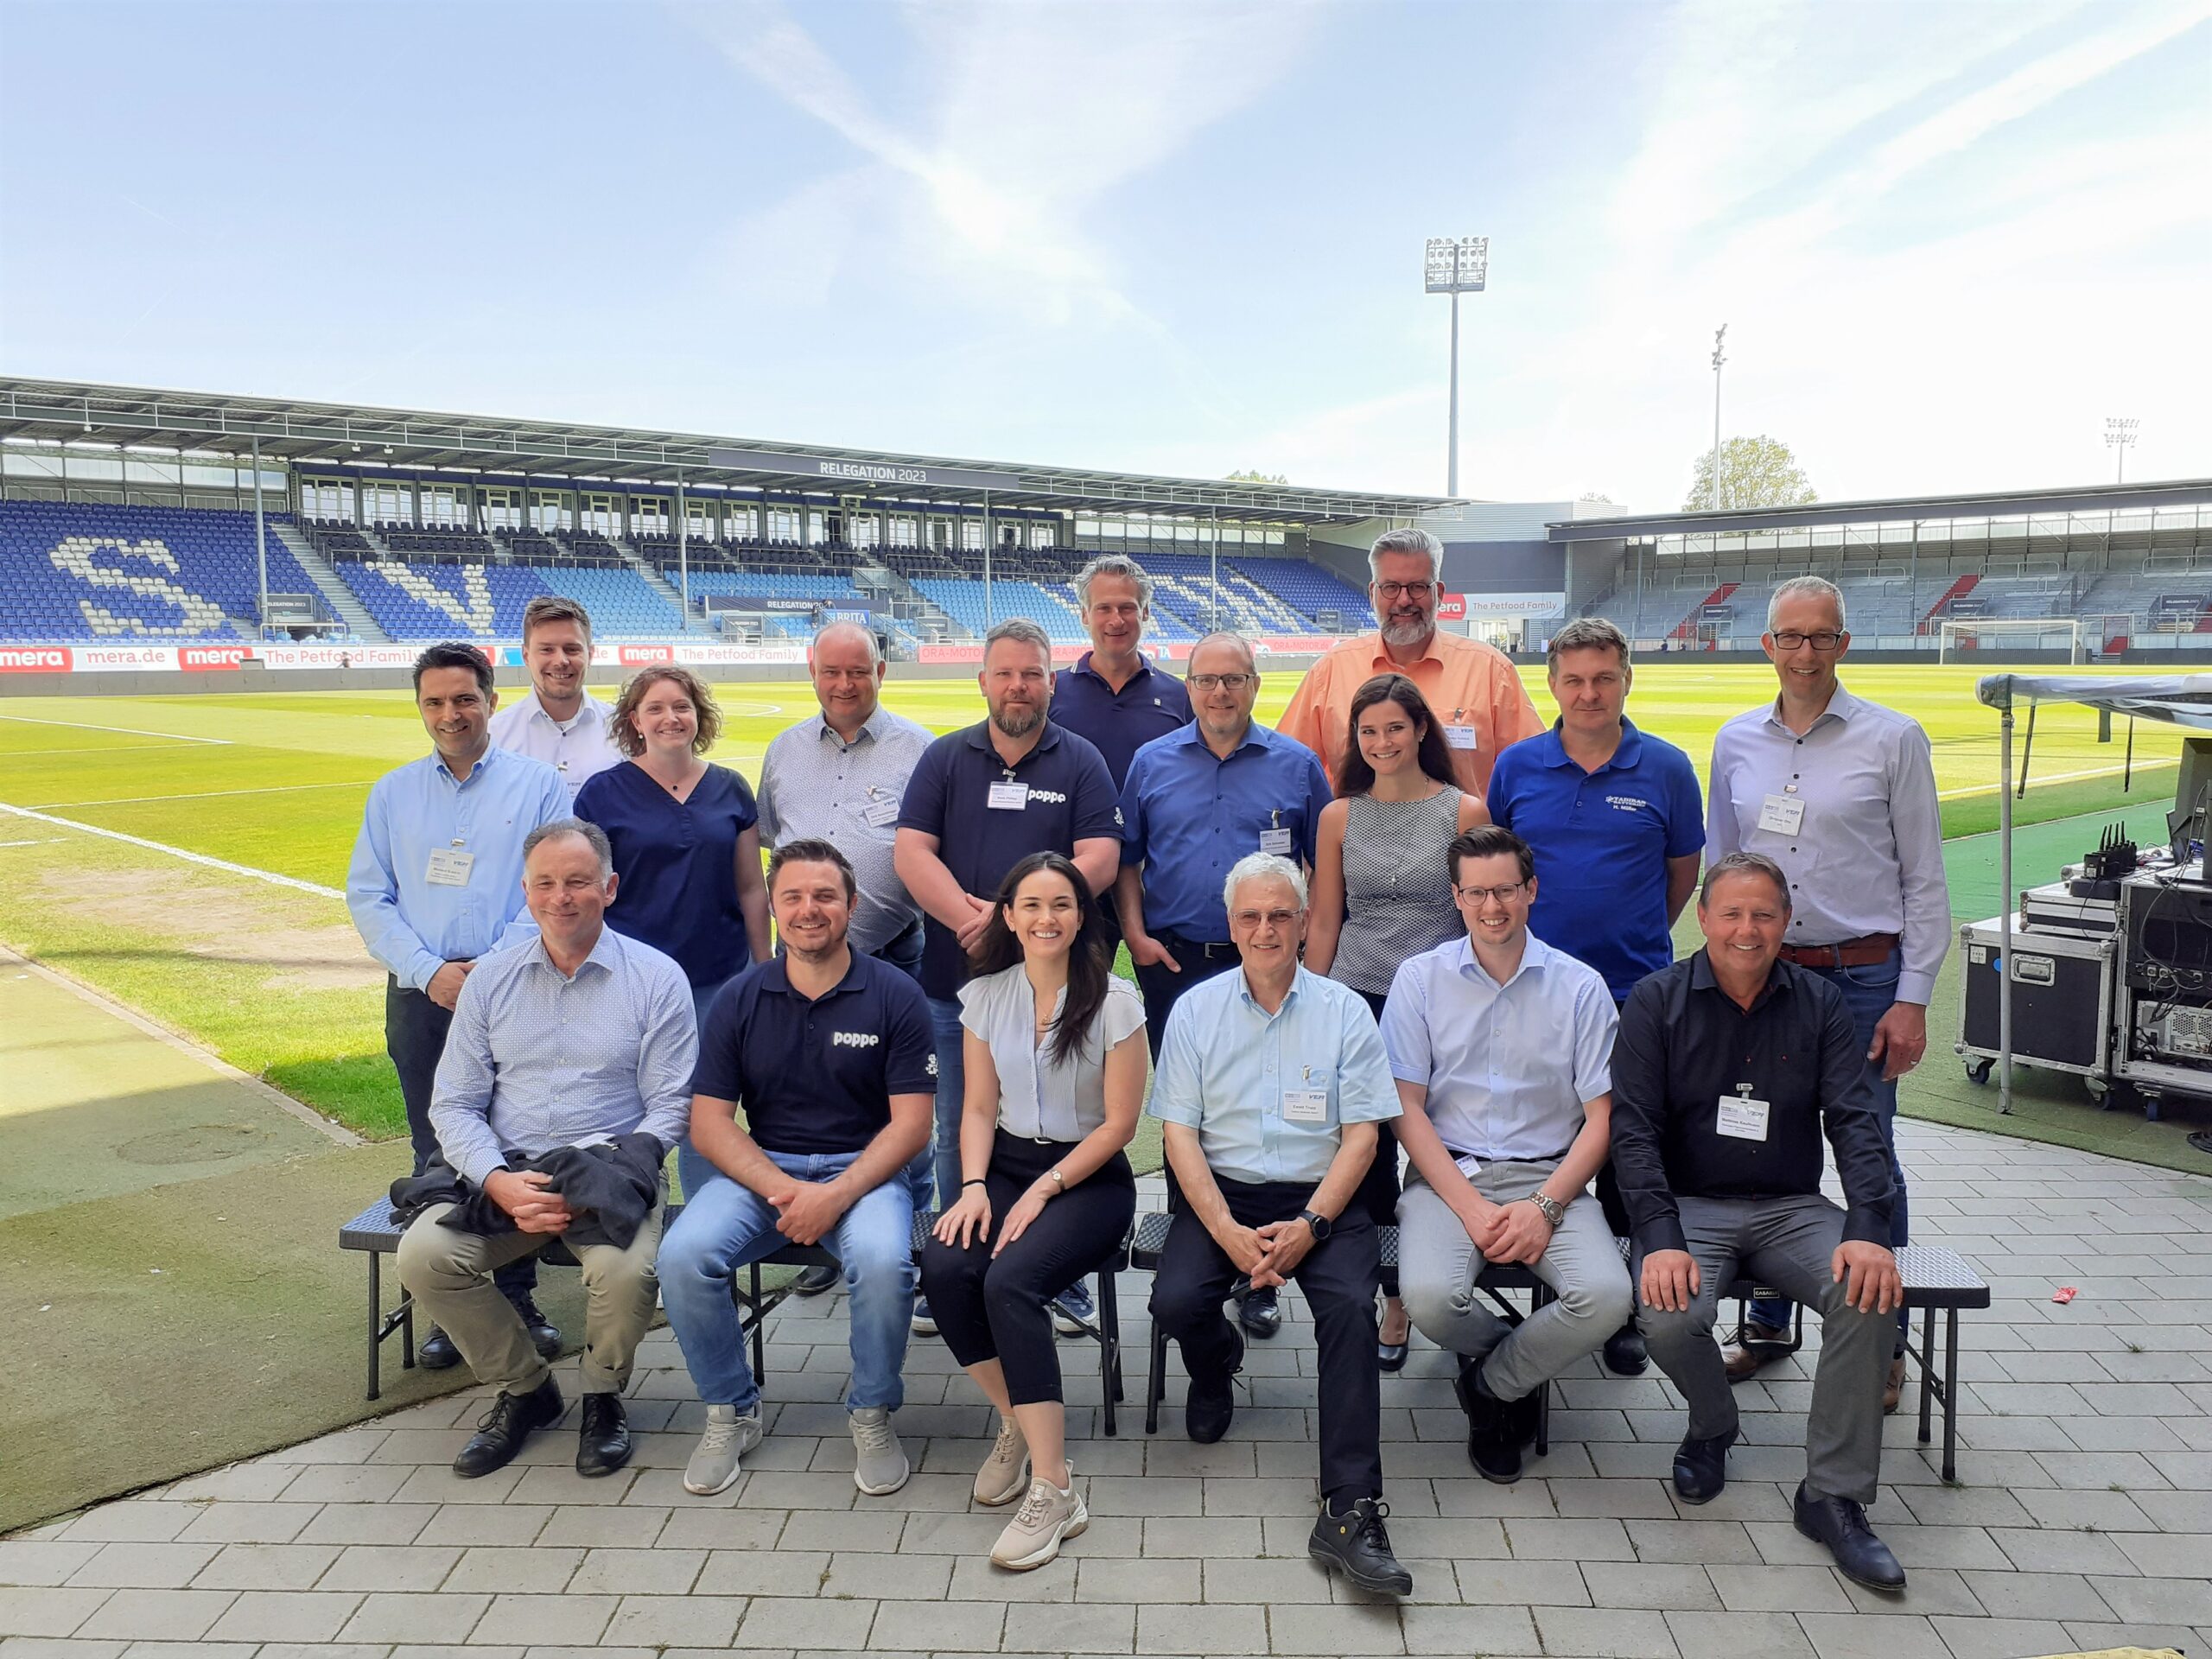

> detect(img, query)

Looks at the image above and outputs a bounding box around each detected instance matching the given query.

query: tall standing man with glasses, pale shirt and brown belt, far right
[1706,575,1951,1411]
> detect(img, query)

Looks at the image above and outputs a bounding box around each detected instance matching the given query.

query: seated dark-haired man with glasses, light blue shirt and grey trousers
[1382,825,1630,1484]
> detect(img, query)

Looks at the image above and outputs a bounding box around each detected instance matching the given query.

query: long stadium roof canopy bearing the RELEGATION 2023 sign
[0,376,1458,524]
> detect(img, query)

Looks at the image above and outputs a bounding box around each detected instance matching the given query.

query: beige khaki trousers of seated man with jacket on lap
[400,1188,668,1394]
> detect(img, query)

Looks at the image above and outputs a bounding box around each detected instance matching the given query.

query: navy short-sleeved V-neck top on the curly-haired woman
[575,761,761,987]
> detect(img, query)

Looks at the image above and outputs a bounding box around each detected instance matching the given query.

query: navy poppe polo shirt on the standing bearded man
[898,719,1122,1002]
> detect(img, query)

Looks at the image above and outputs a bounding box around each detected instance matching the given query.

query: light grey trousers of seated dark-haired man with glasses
[1398,1164,1630,1400]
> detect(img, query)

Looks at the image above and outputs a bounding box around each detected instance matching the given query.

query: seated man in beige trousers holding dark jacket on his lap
[394,818,696,1478]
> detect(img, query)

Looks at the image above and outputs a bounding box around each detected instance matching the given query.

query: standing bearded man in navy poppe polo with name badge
[892,617,1122,1334]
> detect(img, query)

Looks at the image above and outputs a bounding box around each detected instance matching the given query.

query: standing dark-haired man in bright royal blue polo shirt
[1489,617,1706,1376]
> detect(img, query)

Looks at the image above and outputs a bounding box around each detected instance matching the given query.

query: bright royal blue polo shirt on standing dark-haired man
[1486,719,1706,1002]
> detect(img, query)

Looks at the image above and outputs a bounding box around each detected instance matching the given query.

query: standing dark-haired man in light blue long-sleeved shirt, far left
[345,641,569,1371]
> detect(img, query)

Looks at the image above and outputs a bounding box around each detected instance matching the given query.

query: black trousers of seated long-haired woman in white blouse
[923,1130,1137,1405]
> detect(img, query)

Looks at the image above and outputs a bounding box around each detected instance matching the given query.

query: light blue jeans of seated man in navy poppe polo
[659,1148,913,1414]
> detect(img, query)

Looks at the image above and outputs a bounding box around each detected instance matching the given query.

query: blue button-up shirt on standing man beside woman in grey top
[1122,721,1330,943]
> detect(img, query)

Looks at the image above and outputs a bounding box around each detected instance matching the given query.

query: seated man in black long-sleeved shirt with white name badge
[1612,852,1904,1591]
